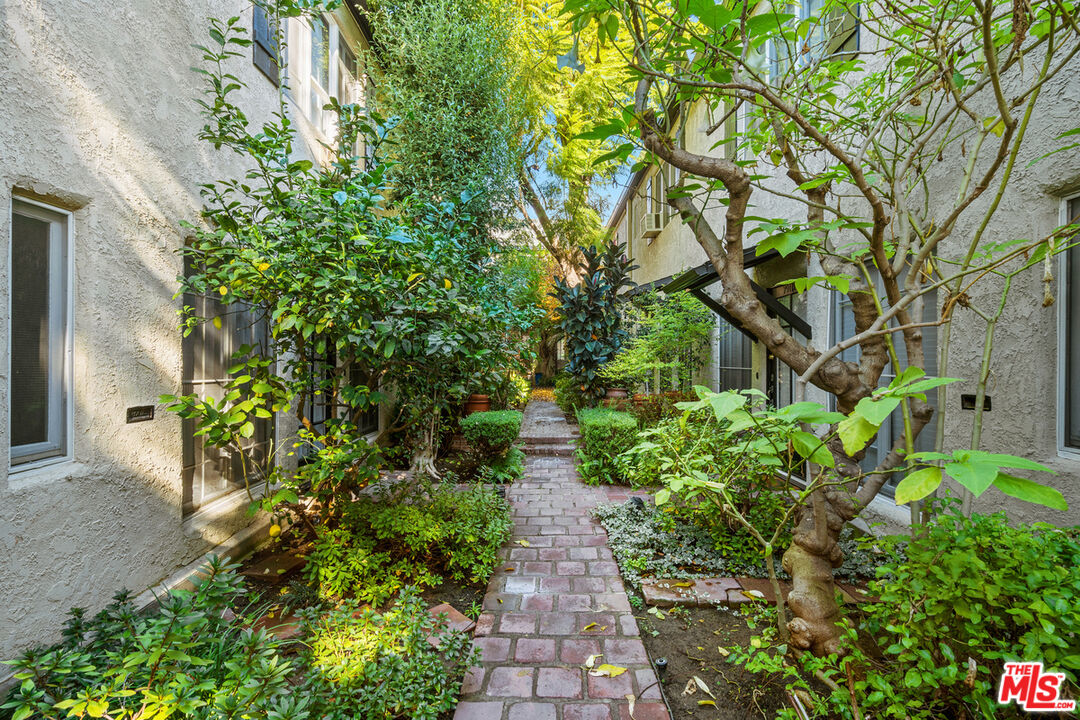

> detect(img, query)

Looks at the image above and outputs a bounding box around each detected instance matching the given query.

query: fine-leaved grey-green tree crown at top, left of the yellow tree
[368,0,524,213]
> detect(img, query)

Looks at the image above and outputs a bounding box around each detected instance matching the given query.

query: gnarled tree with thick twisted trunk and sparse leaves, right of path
[566,0,1080,653]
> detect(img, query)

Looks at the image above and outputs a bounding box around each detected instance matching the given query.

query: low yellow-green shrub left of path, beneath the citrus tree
[305,484,511,604]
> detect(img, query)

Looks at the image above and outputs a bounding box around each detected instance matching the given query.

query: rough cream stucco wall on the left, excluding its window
[0,0,369,660]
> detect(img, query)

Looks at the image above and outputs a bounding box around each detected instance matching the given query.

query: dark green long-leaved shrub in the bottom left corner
[2,558,307,720]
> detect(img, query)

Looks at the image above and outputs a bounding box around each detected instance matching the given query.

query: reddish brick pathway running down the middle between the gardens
[454,403,670,720]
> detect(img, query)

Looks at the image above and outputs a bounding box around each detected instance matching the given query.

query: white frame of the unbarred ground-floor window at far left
[8,194,75,475]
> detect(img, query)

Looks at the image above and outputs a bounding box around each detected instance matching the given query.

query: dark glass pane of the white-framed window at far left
[11,214,51,447]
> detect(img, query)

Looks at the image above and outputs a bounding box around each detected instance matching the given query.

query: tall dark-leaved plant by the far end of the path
[555,243,637,398]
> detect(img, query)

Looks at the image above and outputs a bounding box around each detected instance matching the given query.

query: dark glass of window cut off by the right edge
[1059,195,1080,450]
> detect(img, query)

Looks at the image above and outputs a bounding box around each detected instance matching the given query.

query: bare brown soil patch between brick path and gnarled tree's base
[637,608,787,720]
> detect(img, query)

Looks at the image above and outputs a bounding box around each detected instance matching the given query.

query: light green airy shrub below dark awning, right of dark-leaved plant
[600,291,714,392]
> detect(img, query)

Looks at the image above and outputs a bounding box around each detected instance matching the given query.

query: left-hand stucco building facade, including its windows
[0,0,378,664]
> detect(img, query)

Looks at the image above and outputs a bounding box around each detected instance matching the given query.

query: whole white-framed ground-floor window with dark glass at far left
[8,199,71,465]
